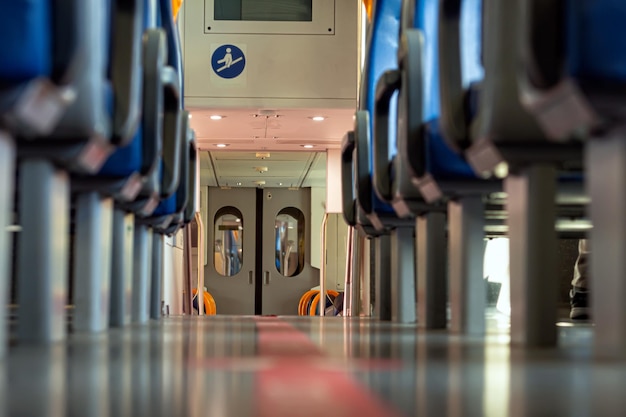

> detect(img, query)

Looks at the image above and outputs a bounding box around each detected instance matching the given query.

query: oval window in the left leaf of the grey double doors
[213,207,243,277]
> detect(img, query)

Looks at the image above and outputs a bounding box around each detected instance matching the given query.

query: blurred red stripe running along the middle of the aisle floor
[255,317,397,417]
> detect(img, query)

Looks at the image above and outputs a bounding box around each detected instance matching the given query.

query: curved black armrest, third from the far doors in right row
[372,70,402,203]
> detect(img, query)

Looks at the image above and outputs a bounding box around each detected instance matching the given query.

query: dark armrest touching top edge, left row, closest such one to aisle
[110,0,144,146]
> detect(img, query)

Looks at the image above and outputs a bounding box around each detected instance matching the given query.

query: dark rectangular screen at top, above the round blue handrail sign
[214,0,313,22]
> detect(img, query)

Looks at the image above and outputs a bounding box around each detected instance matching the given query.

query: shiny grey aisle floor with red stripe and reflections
[0,311,626,417]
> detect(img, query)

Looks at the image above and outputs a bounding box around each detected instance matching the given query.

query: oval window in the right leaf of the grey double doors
[274,207,304,277]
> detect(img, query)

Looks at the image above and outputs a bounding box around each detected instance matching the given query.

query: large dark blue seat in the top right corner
[520,0,626,142]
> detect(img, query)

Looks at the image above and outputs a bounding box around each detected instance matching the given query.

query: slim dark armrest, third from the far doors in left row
[161,67,180,199]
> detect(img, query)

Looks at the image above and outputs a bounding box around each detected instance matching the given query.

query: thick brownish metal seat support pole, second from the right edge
[504,164,558,347]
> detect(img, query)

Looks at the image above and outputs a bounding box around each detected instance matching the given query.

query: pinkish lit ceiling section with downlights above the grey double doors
[191,108,354,187]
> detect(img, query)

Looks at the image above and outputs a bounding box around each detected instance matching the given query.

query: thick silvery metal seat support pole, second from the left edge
[17,159,70,343]
